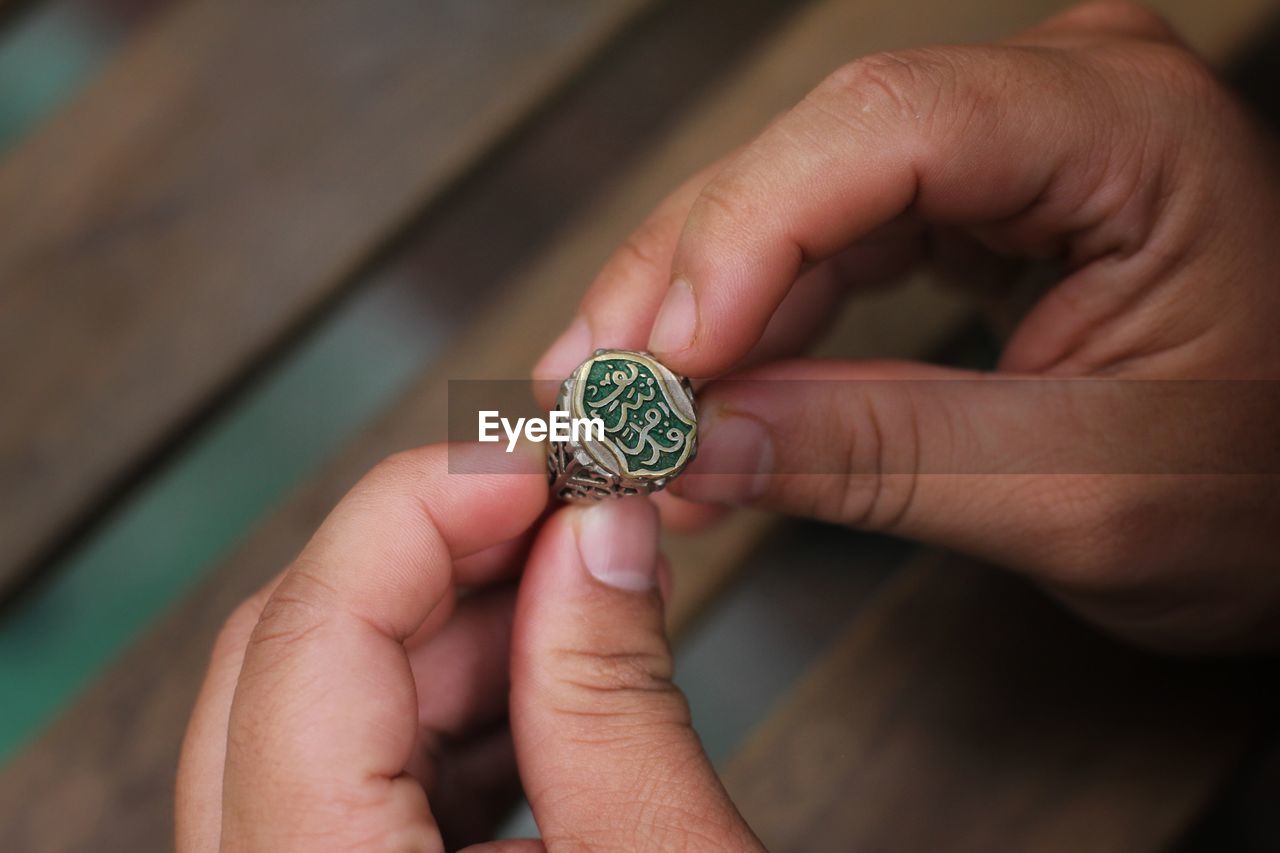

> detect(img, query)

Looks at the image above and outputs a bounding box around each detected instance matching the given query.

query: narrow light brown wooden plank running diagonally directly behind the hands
[0,0,1269,850]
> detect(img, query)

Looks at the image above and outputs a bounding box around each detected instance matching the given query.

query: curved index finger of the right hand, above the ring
[648,31,1194,377]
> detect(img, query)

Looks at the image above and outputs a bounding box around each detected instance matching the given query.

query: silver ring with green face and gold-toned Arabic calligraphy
[547,350,698,501]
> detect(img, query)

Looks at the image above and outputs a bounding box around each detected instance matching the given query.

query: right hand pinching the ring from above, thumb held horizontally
[535,3,1280,649]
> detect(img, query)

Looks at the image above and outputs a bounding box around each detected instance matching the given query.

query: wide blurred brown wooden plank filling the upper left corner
[0,0,650,592]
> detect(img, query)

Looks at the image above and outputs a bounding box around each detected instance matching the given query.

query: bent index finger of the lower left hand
[223,446,547,850]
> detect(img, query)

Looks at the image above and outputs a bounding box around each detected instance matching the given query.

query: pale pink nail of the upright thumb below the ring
[577,498,658,592]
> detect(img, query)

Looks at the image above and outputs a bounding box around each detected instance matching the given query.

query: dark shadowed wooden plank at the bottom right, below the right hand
[724,556,1256,853]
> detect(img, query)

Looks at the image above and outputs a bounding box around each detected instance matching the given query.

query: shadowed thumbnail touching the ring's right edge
[672,410,773,503]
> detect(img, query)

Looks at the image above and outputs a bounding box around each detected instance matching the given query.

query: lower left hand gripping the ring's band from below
[177,446,759,853]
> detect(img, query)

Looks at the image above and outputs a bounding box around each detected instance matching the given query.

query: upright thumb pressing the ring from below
[511,498,759,850]
